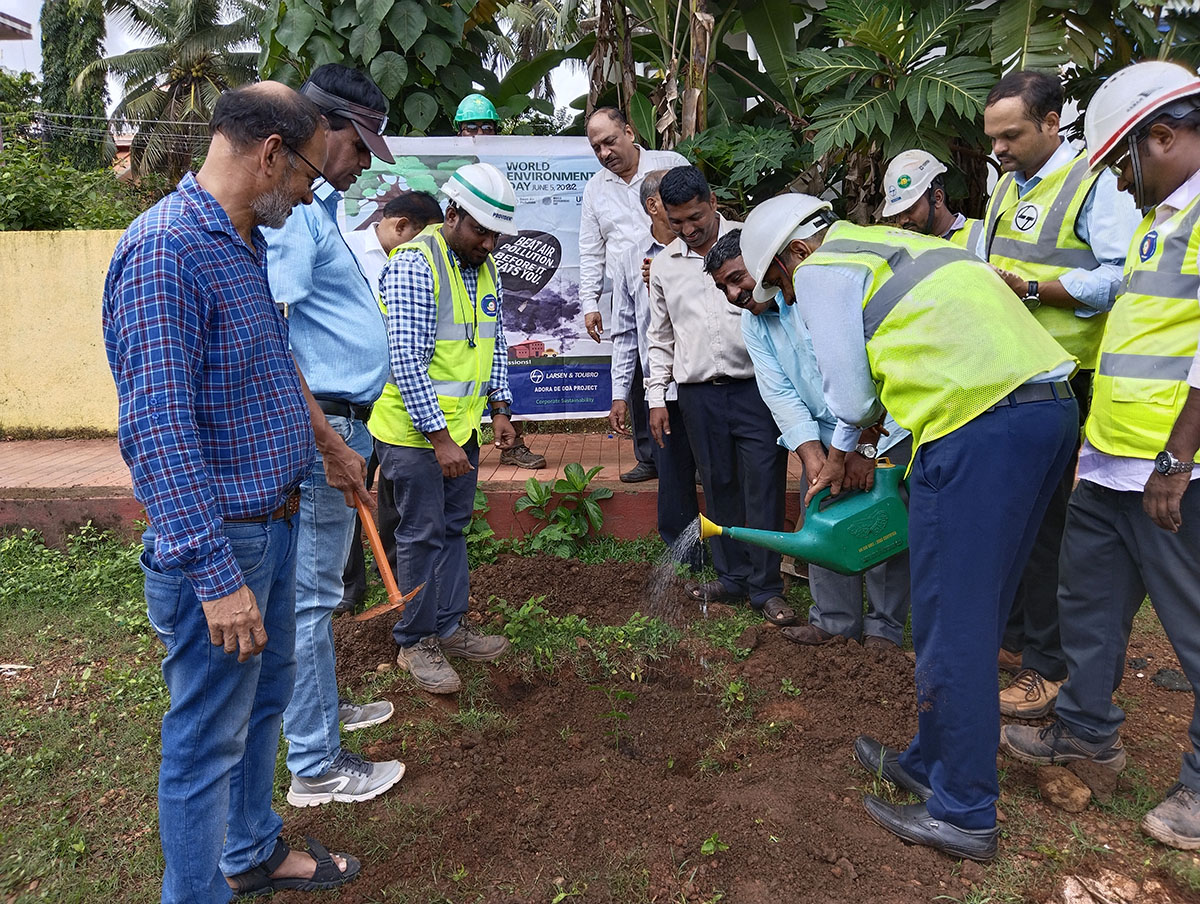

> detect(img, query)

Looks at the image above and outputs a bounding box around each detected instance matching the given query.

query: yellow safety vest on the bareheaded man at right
[984,154,1105,370]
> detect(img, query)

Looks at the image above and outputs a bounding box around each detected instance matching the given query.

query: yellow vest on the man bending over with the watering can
[798,222,1072,449]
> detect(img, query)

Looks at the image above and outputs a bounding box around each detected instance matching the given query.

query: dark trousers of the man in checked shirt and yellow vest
[376,438,479,647]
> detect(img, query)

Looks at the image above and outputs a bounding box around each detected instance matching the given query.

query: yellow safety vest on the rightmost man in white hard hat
[1084,192,1200,459]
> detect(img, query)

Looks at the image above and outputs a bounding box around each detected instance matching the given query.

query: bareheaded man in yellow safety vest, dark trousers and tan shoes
[978,72,1139,719]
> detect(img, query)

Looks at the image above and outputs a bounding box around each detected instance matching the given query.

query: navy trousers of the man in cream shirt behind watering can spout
[679,379,787,607]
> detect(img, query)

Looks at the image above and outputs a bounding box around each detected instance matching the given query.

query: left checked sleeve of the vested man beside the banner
[379,250,446,433]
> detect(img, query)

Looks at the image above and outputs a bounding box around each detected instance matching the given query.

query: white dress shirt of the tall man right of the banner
[580,145,688,315]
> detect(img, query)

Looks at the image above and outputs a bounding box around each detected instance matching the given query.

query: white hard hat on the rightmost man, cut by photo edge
[1084,61,1200,170]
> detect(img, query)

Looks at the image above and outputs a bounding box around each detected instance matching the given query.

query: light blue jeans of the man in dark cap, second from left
[283,414,371,778]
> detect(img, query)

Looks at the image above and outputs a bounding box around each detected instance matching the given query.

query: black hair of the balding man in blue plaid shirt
[209,83,320,150]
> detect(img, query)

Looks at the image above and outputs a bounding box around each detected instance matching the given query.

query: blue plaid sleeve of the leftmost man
[106,237,245,601]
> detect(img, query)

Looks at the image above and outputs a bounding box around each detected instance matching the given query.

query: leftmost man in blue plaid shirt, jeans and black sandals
[103,82,360,904]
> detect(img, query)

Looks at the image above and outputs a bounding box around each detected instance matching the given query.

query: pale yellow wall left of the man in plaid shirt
[0,231,121,431]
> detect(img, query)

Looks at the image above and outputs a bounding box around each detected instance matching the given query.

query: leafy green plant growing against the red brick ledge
[514,461,612,558]
